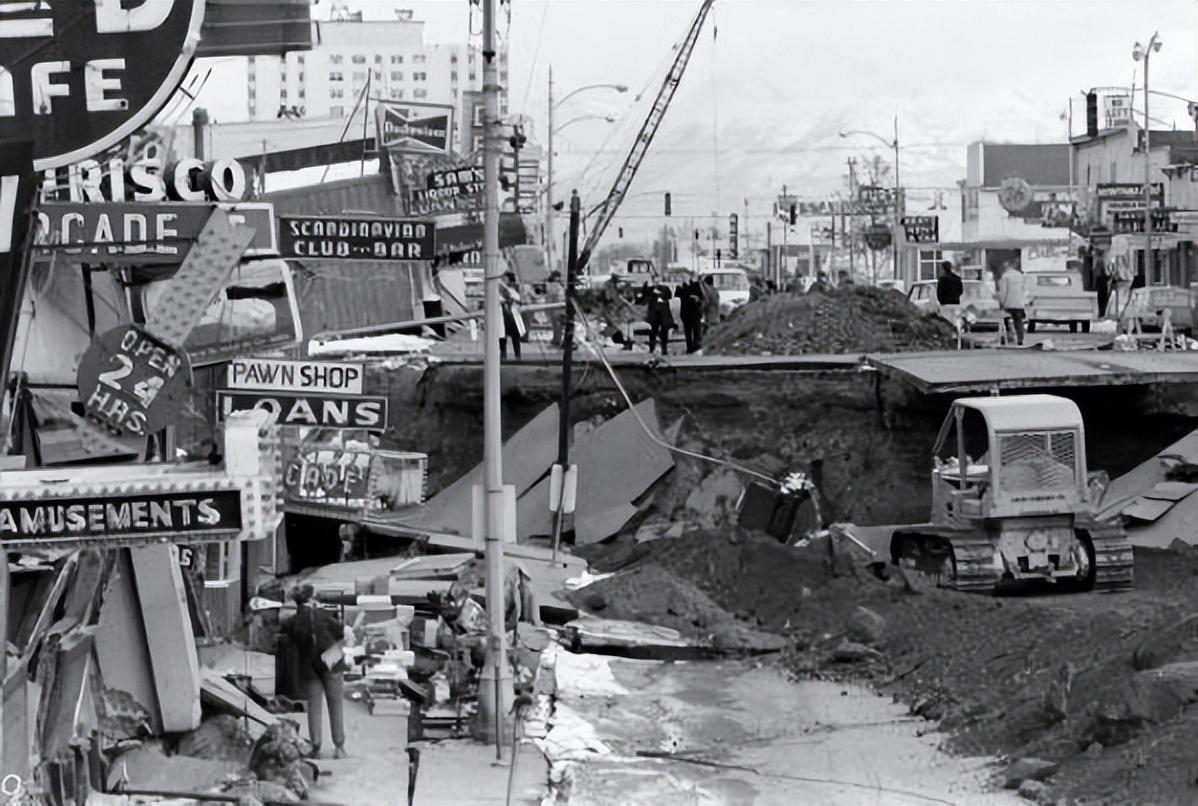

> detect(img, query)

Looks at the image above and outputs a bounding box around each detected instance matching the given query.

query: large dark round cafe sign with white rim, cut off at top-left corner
[0,0,205,171]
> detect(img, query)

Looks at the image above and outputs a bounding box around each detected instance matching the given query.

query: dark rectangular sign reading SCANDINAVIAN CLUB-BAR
[279,216,436,260]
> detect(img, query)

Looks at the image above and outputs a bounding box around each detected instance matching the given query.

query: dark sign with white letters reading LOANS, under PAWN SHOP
[217,389,387,431]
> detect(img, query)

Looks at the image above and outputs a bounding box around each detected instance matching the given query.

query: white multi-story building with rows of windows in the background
[190,4,508,151]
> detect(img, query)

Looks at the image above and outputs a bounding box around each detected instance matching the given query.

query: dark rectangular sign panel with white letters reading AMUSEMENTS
[0,490,242,544]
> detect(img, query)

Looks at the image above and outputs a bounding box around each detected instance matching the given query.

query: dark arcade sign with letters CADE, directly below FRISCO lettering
[37,201,278,265]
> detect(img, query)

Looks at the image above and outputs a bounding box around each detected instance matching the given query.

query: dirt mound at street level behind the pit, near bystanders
[703,286,956,356]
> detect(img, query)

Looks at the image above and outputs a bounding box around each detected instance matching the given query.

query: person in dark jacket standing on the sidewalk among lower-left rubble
[282,584,345,758]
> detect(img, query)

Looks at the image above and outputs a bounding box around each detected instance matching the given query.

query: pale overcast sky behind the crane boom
[316,0,1198,239]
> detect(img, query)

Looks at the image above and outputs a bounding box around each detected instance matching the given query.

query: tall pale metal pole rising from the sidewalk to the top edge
[478,0,514,759]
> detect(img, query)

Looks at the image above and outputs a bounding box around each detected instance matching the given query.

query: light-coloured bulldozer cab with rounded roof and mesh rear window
[932,394,1090,526]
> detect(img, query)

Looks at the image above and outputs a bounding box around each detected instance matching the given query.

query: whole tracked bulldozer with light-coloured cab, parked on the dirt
[890,394,1133,593]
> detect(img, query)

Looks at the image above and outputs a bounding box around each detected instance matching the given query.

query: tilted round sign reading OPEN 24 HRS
[75,325,192,435]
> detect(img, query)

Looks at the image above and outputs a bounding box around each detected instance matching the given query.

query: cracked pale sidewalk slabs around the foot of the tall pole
[309,699,549,806]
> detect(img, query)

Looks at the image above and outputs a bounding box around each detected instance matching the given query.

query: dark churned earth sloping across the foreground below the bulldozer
[582,529,1198,804]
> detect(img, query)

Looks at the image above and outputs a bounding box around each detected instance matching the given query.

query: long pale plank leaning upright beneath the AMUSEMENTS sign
[129,545,200,733]
